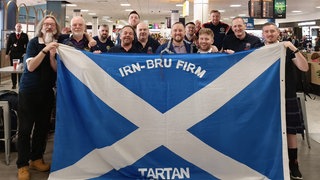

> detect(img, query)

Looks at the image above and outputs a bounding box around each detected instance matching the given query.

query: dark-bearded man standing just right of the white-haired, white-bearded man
[91,24,114,54]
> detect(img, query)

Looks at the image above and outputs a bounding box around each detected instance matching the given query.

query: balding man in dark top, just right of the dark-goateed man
[134,23,160,54]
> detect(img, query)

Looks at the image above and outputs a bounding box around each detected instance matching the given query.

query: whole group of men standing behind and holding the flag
[7,7,308,179]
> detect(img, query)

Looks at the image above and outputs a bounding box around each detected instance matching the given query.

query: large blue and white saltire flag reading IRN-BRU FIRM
[49,43,289,180]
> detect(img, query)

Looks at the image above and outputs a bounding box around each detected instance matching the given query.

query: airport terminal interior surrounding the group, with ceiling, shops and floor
[0,0,320,180]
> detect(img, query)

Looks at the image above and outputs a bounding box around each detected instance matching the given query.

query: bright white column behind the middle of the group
[193,0,209,23]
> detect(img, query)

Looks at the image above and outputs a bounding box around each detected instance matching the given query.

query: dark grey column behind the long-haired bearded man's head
[47,0,67,27]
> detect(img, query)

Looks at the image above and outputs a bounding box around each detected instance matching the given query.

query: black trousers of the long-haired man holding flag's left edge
[17,91,54,168]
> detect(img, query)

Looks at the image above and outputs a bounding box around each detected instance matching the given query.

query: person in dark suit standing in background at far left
[6,23,29,89]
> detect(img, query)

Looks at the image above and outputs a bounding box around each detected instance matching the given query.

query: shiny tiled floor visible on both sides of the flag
[0,81,320,180]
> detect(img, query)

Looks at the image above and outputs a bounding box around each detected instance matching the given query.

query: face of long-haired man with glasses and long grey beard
[41,18,57,44]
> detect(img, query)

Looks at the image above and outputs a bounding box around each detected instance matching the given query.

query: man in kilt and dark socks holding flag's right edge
[262,22,309,179]
